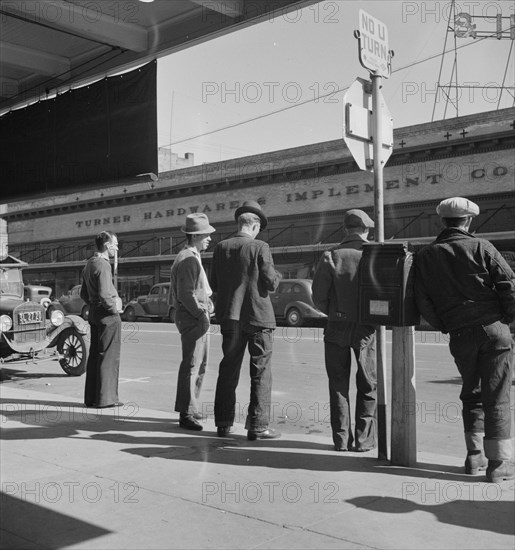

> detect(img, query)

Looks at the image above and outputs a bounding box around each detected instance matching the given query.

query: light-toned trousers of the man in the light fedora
[175,309,209,415]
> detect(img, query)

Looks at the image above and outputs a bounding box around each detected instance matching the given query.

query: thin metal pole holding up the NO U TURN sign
[370,74,388,460]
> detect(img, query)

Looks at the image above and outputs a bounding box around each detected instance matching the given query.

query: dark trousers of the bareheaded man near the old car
[84,305,122,407]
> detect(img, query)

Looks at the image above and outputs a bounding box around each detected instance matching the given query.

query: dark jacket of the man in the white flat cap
[415,228,515,332]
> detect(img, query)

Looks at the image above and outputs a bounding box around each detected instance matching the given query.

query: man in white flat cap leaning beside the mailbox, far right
[415,197,515,483]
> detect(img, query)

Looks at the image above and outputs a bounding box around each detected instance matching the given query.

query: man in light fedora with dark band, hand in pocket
[169,214,215,431]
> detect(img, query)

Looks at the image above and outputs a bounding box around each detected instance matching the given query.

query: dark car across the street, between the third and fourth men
[270,279,327,327]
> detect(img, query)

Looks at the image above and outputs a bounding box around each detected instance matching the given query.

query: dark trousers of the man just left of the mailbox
[324,323,377,450]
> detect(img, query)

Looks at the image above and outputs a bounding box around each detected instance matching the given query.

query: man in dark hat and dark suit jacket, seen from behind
[211,201,281,441]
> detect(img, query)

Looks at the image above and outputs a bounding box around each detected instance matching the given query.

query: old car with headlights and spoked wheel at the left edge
[0,255,89,376]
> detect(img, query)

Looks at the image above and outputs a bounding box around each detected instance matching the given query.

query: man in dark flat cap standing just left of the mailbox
[312,209,377,452]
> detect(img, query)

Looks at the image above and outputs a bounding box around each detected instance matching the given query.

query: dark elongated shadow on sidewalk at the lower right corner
[346,496,515,546]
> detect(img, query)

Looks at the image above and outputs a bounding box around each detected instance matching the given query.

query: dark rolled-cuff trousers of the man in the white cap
[449,321,513,440]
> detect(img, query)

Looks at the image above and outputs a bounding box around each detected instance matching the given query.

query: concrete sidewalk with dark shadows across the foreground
[0,385,515,550]
